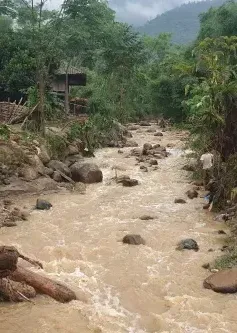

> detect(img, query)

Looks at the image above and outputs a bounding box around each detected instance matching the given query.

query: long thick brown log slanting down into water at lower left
[10,265,77,303]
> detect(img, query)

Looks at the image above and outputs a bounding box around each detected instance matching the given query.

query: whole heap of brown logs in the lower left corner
[0,246,77,303]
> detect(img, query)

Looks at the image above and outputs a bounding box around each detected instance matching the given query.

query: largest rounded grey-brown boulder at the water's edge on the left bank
[71,163,103,184]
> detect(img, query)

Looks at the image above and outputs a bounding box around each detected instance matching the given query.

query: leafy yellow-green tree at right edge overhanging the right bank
[187,36,237,160]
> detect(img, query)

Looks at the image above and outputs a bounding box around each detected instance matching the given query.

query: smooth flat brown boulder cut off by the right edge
[203,268,237,294]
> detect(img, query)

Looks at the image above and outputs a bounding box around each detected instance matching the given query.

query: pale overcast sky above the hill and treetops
[49,0,202,26]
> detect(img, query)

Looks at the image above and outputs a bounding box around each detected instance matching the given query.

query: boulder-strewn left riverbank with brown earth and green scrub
[0,123,134,197]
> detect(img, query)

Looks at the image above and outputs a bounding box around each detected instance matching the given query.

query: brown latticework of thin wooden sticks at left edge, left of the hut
[0,102,31,124]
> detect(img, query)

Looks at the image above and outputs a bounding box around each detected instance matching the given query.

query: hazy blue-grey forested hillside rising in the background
[138,0,228,44]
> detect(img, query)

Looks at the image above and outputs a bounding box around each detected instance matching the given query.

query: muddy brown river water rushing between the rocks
[0,125,237,333]
